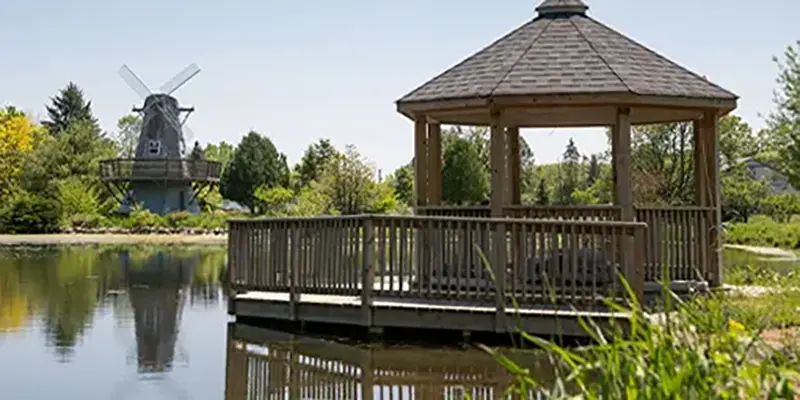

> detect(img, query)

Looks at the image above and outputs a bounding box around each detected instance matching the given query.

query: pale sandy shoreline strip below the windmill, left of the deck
[0,233,228,247]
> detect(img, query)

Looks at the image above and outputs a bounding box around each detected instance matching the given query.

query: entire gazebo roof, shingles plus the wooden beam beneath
[397,0,738,127]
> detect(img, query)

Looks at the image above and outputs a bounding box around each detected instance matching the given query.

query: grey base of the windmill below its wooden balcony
[119,183,205,215]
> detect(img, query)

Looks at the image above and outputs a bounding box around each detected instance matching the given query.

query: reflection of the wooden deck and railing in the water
[225,323,550,400]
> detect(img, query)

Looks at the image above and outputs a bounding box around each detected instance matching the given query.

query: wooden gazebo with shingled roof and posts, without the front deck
[397,0,737,286]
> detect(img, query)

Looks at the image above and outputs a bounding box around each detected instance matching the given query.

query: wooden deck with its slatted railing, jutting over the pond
[228,215,702,336]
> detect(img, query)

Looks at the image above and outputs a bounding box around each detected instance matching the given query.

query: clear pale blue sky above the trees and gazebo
[0,0,800,173]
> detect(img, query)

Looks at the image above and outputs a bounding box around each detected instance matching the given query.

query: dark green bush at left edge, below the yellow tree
[0,190,61,233]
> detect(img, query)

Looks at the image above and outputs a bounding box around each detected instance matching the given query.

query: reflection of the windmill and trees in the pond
[0,247,225,372]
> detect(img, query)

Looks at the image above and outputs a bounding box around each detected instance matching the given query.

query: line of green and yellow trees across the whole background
[0,42,800,232]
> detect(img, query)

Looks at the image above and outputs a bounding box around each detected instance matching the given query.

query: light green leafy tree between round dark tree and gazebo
[319,145,377,215]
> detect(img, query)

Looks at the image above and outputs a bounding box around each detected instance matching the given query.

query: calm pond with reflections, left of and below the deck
[0,246,780,400]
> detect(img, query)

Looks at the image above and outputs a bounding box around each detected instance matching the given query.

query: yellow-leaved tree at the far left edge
[0,107,41,196]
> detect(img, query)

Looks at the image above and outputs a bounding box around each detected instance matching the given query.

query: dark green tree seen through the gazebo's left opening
[442,136,489,205]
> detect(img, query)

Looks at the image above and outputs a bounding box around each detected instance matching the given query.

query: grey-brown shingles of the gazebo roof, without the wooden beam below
[398,0,737,103]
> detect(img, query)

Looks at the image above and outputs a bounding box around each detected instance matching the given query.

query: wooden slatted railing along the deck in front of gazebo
[228,215,645,309]
